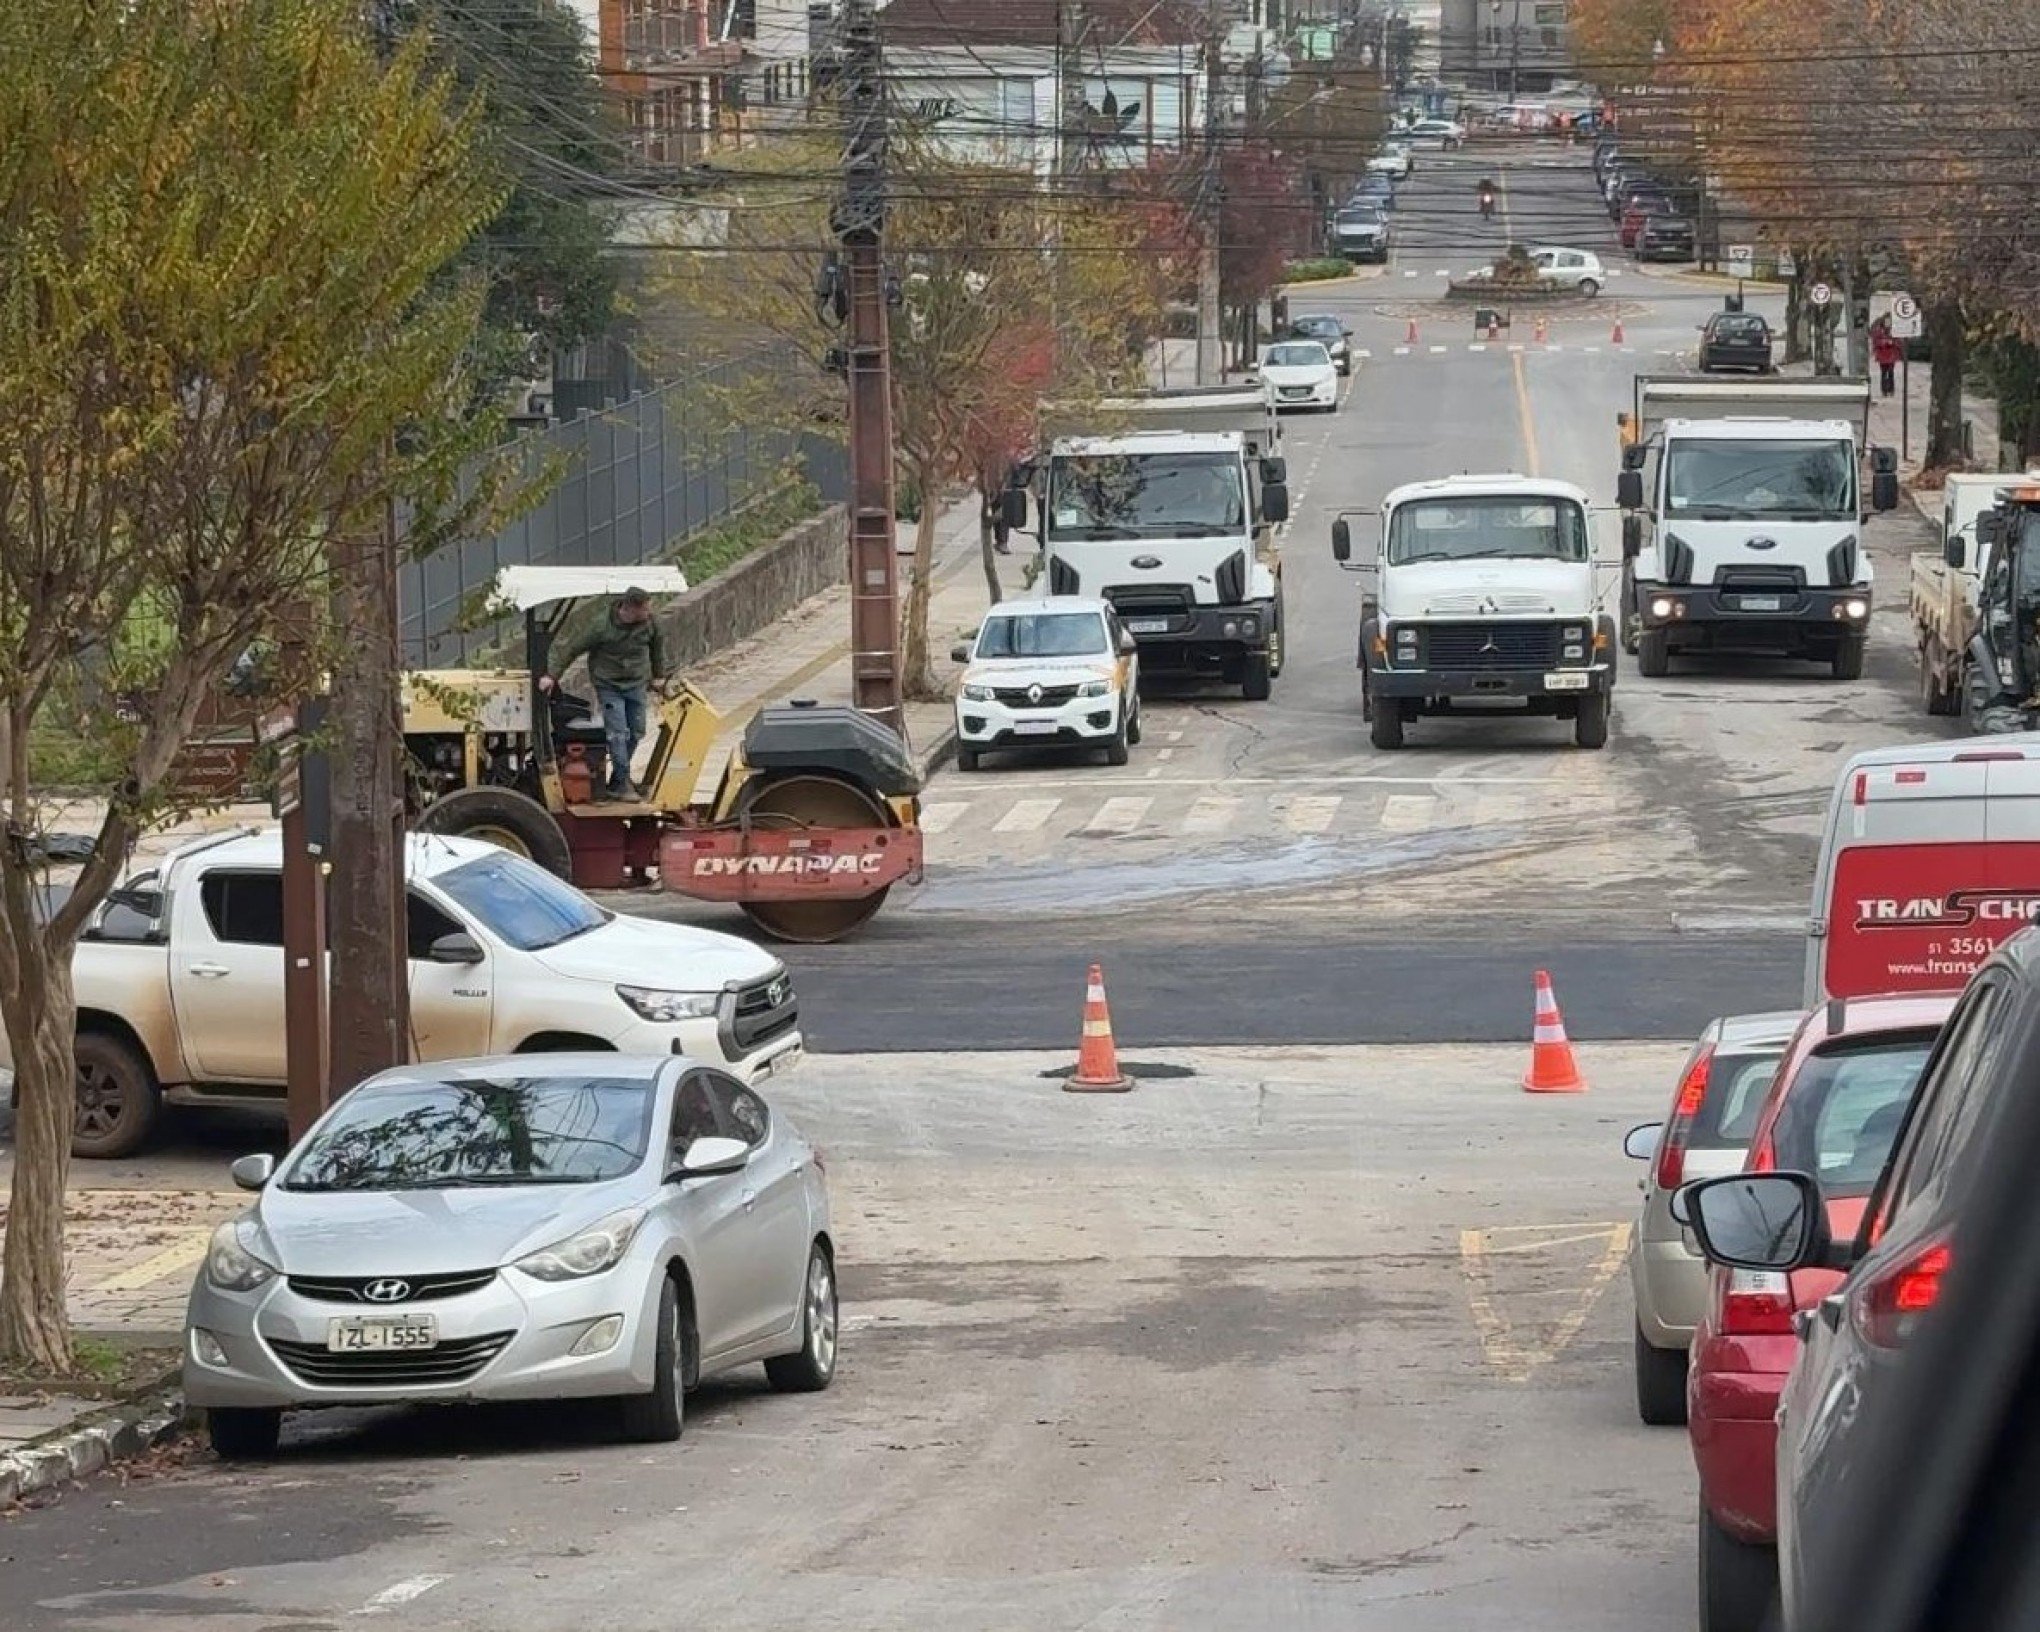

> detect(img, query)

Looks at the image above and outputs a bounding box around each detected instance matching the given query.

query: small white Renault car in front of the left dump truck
[949,599,1142,771]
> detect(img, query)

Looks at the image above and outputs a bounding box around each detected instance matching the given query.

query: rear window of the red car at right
[1771,1032,1934,1200]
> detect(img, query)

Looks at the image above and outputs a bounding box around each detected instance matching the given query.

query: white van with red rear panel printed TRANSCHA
[1803,736,2040,1008]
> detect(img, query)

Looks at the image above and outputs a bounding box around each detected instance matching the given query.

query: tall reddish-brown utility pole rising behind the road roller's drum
[836,0,901,738]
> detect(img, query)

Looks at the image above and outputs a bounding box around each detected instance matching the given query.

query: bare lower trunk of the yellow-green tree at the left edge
[0,942,78,1375]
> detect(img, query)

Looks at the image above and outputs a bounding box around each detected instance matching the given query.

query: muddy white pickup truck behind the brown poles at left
[17,830,802,1157]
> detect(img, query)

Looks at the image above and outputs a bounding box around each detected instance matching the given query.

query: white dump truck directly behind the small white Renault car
[1008,381,1289,702]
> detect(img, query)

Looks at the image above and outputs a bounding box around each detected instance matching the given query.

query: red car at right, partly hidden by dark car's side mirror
[1687,993,1956,1632]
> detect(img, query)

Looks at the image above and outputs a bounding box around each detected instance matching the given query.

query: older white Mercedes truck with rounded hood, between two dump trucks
[1332,473,1616,749]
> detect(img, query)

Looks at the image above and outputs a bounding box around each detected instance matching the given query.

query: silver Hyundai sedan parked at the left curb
[184,1055,836,1457]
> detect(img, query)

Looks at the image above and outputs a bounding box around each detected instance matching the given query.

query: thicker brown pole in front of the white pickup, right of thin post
[326,537,410,1100]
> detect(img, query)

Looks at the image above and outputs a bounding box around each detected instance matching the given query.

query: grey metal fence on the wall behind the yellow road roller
[398,365,843,669]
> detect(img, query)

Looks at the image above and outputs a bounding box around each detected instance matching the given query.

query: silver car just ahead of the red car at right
[1622,1010,1801,1426]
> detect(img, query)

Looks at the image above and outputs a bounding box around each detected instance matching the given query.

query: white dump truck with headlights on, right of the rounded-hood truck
[1616,377,1899,679]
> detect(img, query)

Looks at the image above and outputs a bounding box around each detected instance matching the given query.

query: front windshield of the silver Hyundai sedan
[284,1077,653,1191]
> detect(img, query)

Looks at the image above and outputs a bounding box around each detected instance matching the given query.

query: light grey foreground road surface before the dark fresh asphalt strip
[0,1047,1693,1632]
